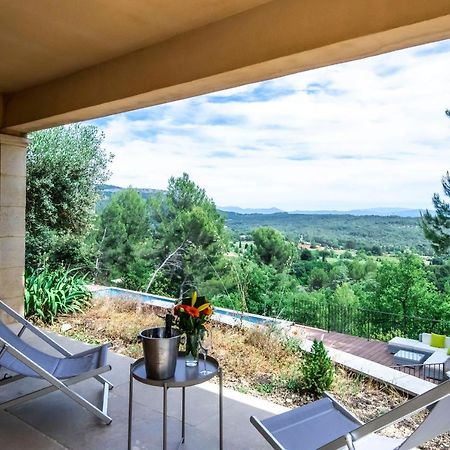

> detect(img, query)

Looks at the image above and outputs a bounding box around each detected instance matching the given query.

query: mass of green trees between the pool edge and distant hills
[97,174,450,339]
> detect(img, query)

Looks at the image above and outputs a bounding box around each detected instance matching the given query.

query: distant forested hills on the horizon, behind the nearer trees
[96,184,431,254]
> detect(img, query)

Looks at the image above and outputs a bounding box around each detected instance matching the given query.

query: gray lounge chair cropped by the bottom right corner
[250,380,450,450]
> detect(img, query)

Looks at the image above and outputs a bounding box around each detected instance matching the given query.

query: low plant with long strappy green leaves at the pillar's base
[25,266,92,323]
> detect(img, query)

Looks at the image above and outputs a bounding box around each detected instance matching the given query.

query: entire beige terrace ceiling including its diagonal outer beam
[0,0,450,134]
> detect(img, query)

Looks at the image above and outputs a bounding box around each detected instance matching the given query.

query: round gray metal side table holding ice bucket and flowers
[128,353,223,450]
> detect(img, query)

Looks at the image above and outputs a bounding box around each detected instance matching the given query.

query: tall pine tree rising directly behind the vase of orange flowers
[150,173,227,296]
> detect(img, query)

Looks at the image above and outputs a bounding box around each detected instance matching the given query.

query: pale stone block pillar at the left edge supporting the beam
[0,134,27,320]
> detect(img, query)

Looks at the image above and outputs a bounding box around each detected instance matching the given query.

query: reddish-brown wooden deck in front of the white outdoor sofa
[298,326,396,367]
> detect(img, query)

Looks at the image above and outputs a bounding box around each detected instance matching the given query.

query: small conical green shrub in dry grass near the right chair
[301,340,334,396]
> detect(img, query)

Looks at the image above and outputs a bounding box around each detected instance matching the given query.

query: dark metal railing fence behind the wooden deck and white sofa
[280,299,450,340]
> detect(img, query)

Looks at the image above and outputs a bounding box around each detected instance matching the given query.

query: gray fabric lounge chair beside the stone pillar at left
[0,301,113,424]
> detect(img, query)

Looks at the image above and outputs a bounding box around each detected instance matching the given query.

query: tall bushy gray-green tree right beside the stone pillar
[26,125,110,268]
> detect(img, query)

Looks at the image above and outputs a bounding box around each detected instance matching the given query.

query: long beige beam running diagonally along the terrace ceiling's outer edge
[0,0,450,134]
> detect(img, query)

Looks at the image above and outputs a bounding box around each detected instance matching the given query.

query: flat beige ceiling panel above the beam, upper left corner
[0,0,269,93]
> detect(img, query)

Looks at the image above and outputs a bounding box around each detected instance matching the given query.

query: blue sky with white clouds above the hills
[92,40,450,211]
